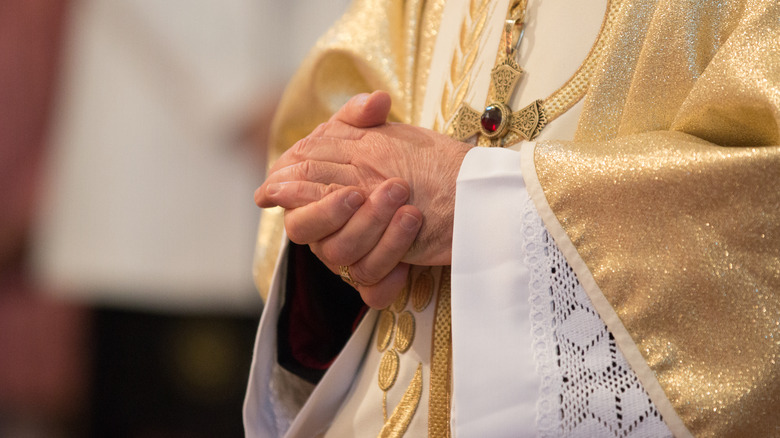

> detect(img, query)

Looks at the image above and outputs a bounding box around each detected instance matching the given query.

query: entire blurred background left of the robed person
[0,0,347,438]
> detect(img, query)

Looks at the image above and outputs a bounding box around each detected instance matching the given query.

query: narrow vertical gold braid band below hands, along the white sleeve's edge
[428,266,452,438]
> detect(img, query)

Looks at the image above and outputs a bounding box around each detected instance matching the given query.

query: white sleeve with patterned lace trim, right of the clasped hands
[452,148,671,438]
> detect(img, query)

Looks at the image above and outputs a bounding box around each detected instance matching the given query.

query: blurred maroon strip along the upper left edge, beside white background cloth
[0,0,67,266]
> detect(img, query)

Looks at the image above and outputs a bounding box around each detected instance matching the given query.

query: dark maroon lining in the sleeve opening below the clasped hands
[277,243,367,383]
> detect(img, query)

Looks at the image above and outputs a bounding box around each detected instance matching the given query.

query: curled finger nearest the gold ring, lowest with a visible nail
[350,205,422,285]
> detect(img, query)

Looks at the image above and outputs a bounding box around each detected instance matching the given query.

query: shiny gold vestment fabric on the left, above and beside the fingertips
[253,0,444,298]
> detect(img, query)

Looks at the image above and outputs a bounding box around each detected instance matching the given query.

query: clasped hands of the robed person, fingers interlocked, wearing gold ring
[255,92,471,308]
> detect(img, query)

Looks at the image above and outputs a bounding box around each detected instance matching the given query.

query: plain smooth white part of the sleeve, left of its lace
[451,148,539,438]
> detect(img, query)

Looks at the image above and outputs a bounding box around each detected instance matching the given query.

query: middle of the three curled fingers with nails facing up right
[312,178,409,266]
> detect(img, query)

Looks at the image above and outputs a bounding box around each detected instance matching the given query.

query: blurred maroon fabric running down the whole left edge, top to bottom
[0,0,89,420]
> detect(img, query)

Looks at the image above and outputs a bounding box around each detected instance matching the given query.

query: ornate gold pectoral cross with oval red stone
[448,1,547,146]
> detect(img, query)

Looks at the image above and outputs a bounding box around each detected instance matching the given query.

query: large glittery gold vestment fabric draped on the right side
[524,0,780,437]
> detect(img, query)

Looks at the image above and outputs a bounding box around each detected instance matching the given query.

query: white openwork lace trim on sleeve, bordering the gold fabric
[522,190,672,438]
